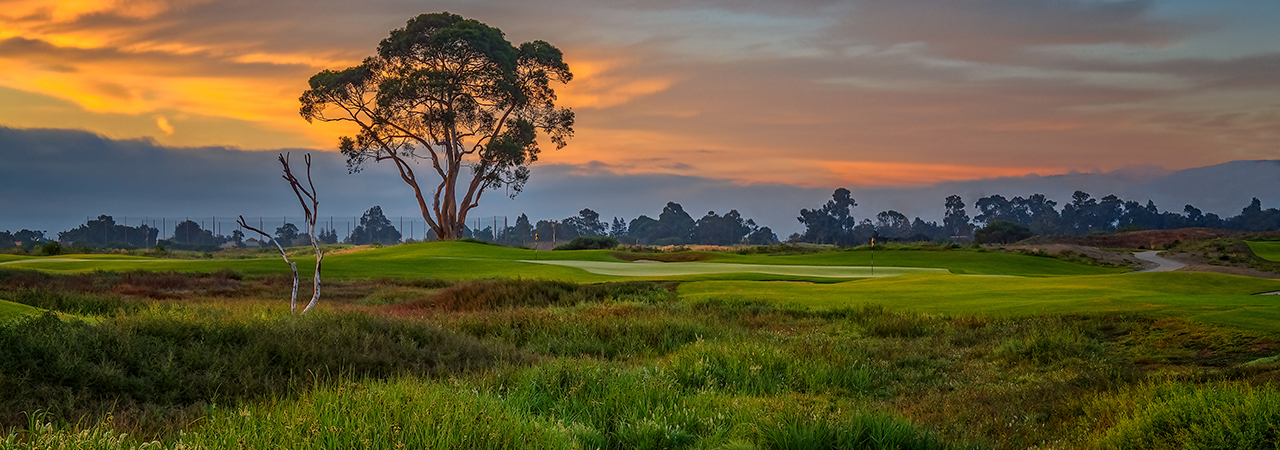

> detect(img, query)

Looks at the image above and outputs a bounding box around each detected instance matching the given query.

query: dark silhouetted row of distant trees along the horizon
[0,188,1280,251]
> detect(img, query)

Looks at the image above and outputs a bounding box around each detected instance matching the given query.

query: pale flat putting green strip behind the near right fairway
[521,260,947,279]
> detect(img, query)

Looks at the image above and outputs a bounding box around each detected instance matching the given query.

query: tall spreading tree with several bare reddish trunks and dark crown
[300,13,573,240]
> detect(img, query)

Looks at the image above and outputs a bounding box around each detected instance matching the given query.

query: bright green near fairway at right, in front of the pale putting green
[680,272,1280,331]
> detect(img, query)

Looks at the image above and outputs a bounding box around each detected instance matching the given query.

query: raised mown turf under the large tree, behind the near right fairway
[0,242,1125,283]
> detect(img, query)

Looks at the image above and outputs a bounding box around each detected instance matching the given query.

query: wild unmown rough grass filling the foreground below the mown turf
[0,272,1280,449]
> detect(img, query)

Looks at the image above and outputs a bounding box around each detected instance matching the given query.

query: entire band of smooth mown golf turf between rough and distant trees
[0,242,1280,330]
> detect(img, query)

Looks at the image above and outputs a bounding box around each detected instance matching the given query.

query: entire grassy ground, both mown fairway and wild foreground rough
[0,243,1280,450]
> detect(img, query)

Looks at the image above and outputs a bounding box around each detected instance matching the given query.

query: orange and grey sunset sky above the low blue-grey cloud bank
[0,0,1280,235]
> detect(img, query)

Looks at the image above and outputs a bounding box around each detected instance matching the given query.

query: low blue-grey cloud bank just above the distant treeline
[0,128,1280,237]
